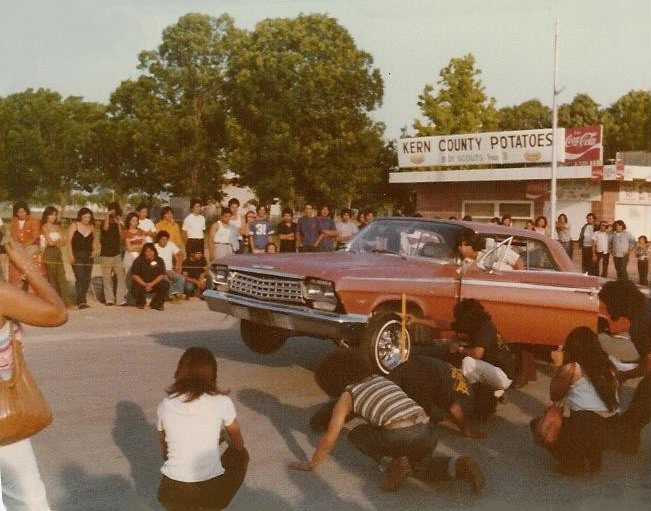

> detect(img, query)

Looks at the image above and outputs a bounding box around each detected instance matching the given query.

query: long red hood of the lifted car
[219,252,455,281]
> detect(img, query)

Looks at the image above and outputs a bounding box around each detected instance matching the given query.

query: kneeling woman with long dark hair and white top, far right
[536,327,619,474]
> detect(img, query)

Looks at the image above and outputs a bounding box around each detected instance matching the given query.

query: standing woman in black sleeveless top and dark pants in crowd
[68,208,95,309]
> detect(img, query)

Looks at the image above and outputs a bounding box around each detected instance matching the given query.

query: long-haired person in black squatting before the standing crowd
[131,243,169,311]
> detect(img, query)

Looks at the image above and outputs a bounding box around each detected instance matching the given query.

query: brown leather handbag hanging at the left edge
[0,323,52,445]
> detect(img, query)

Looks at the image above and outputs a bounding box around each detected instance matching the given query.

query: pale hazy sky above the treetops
[0,0,651,138]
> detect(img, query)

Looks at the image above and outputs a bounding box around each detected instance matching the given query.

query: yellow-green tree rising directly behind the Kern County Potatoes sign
[414,53,499,136]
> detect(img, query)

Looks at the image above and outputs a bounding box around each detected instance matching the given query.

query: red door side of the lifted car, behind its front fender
[460,239,599,346]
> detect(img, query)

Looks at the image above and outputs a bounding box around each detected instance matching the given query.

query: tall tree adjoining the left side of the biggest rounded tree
[134,13,239,196]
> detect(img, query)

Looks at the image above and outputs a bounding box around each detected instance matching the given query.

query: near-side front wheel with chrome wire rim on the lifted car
[358,312,411,374]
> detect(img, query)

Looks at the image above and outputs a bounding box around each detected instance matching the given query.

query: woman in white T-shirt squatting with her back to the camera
[158,347,249,511]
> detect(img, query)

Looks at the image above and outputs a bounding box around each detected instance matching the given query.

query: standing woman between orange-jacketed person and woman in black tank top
[41,206,72,307]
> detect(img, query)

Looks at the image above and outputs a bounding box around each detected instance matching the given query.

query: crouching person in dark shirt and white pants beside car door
[452,298,515,404]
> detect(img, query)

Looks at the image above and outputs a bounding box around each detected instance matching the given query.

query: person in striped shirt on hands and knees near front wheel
[290,350,483,491]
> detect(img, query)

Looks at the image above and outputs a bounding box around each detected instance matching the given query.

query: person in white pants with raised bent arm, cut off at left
[0,242,68,511]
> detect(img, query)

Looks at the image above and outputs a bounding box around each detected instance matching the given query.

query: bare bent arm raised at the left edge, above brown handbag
[0,243,68,326]
